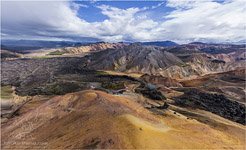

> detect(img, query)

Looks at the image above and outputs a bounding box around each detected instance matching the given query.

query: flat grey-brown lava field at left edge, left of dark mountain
[1,57,83,86]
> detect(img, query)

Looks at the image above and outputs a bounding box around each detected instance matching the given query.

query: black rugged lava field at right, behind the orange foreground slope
[175,89,246,125]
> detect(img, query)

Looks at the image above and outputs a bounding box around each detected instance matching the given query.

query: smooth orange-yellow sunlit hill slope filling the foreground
[1,90,245,149]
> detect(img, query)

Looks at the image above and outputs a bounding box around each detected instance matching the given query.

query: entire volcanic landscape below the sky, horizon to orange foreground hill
[1,41,246,149]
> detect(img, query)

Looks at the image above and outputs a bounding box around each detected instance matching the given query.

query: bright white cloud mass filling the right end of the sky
[161,0,246,42]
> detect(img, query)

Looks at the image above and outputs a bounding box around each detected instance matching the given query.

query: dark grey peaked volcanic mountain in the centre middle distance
[86,44,183,74]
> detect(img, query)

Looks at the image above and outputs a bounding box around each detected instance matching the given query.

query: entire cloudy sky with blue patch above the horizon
[1,0,246,43]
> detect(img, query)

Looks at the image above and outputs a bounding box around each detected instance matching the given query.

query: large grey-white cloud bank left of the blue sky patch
[1,1,90,38]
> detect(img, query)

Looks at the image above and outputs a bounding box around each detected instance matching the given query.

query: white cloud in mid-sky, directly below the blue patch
[93,5,158,41]
